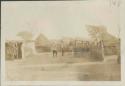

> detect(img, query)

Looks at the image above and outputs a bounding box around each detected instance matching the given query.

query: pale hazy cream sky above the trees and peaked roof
[1,0,119,39]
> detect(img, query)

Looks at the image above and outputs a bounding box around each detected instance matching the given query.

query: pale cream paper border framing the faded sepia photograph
[1,0,125,86]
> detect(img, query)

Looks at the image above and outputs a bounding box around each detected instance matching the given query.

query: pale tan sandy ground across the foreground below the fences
[6,53,121,81]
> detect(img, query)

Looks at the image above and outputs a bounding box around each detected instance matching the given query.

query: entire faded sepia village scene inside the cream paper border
[1,0,124,86]
